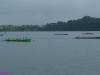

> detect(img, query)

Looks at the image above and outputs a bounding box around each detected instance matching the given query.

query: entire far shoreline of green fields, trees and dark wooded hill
[0,16,100,31]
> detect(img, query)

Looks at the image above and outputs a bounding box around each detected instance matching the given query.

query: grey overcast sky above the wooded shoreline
[0,0,100,25]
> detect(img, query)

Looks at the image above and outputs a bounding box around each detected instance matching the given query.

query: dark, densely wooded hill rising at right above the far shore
[46,16,100,31]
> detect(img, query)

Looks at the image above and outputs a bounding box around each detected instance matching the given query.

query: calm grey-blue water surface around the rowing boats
[0,31,100,75]
